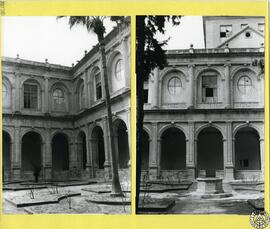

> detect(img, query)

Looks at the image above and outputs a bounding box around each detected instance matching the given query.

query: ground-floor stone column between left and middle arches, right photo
[186,122,195,180]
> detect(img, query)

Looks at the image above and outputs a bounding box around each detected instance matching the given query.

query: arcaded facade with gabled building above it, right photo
[142,17,264,181]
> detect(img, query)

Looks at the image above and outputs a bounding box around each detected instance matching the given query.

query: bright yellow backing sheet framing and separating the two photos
[0,0,269,229]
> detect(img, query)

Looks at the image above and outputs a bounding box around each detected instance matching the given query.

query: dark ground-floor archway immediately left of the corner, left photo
[52,133,69,171]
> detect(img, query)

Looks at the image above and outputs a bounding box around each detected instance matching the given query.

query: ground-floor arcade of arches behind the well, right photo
[142,125,264,180]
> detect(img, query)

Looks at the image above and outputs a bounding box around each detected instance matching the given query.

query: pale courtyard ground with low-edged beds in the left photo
[2,183,131,214]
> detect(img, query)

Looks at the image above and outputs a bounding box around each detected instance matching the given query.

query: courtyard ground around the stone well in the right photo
[140,182,264,215]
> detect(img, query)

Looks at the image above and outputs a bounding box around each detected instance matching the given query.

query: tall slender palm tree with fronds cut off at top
[57,16,124,196]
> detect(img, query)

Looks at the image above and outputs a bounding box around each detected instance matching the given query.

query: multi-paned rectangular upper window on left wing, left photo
[24,84,38,109]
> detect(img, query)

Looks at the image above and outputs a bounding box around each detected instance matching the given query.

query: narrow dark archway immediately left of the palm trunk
[92,126,105,169]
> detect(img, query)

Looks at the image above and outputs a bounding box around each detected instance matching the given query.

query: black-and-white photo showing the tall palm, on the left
[2,16,131,214]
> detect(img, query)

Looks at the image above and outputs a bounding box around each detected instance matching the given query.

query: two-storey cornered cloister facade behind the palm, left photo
[2,21,130,180]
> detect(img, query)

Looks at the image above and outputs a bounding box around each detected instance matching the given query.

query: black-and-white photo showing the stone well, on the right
[136,15,265,215]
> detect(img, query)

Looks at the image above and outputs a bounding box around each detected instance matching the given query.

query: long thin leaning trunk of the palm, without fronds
[98,34,123,196]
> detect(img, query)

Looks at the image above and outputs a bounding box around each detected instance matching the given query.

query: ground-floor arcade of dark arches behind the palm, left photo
[2,119,130,180]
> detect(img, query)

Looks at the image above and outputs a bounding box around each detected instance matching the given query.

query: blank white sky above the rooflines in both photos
[2,16,204,66]
